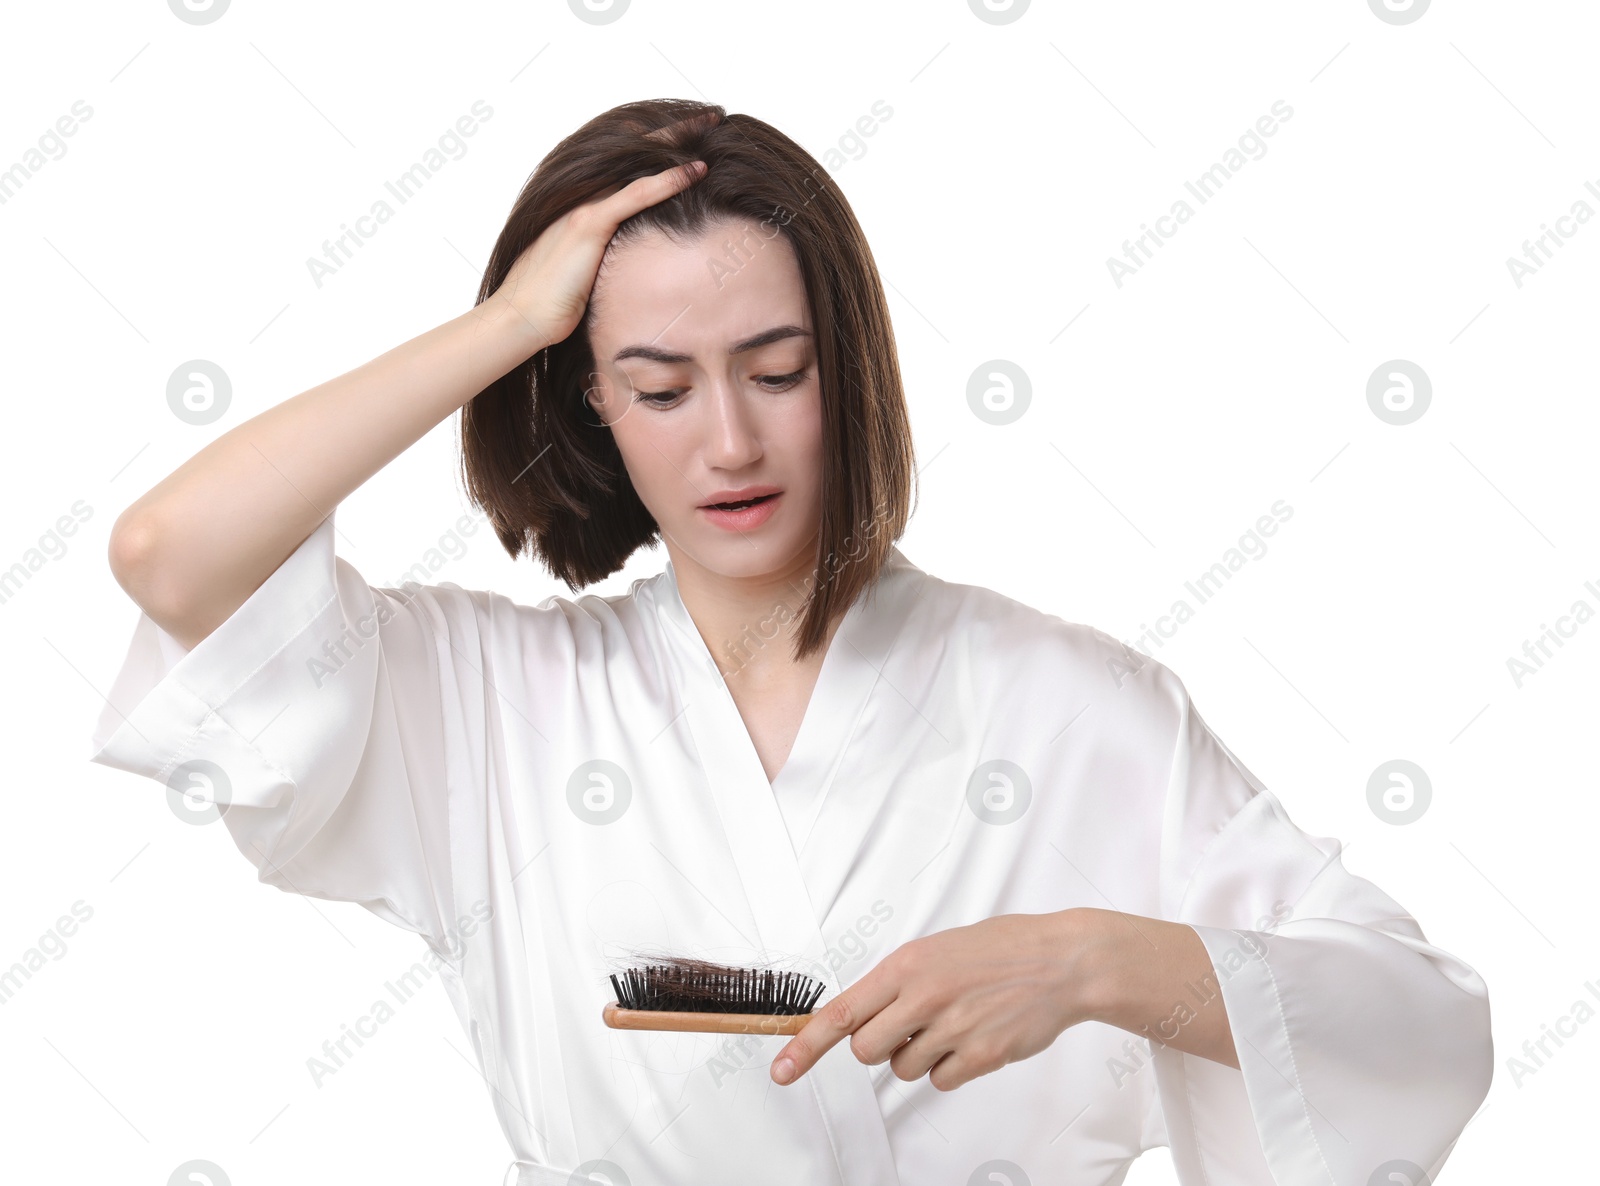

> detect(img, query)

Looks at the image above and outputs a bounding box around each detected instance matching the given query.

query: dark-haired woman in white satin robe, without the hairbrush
[94,101,1491,1186]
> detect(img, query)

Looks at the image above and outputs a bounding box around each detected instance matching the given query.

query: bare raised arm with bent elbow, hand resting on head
[109,157,701,650]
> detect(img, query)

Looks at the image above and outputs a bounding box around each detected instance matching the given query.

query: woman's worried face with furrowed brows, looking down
[587,221,822,578]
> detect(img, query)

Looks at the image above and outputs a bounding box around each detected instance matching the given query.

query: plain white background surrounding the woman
[0,0,1600,1184]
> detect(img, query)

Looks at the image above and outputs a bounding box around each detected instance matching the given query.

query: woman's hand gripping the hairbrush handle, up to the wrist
[771,909,1102,1092]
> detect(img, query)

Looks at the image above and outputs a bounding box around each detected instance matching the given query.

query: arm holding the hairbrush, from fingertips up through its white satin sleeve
[773,662,1494,1186]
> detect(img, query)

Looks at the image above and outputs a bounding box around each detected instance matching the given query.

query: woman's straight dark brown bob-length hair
[461,99,915,659]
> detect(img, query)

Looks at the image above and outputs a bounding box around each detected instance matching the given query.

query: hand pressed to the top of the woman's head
[490,162,707,349]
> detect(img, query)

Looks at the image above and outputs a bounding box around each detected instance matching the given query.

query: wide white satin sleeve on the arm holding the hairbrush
[1152,664,1494,1186]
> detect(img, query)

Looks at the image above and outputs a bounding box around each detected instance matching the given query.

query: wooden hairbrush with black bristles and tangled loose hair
[600,956,827,1034]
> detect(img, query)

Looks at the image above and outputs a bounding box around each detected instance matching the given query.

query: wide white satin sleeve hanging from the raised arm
[91,515,483,957]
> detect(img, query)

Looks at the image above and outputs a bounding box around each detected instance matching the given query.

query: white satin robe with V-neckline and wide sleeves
[91,517,1493,1186]
